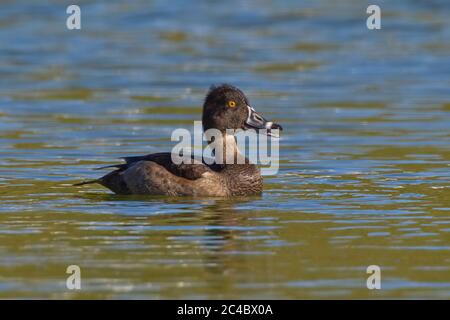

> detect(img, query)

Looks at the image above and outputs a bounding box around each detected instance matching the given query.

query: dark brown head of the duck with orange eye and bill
[202,84,283,137]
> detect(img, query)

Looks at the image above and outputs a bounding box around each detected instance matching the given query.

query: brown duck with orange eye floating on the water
[75,84,282,197]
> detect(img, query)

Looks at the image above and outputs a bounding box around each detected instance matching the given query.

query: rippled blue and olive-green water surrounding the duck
[0,0,450,299]
